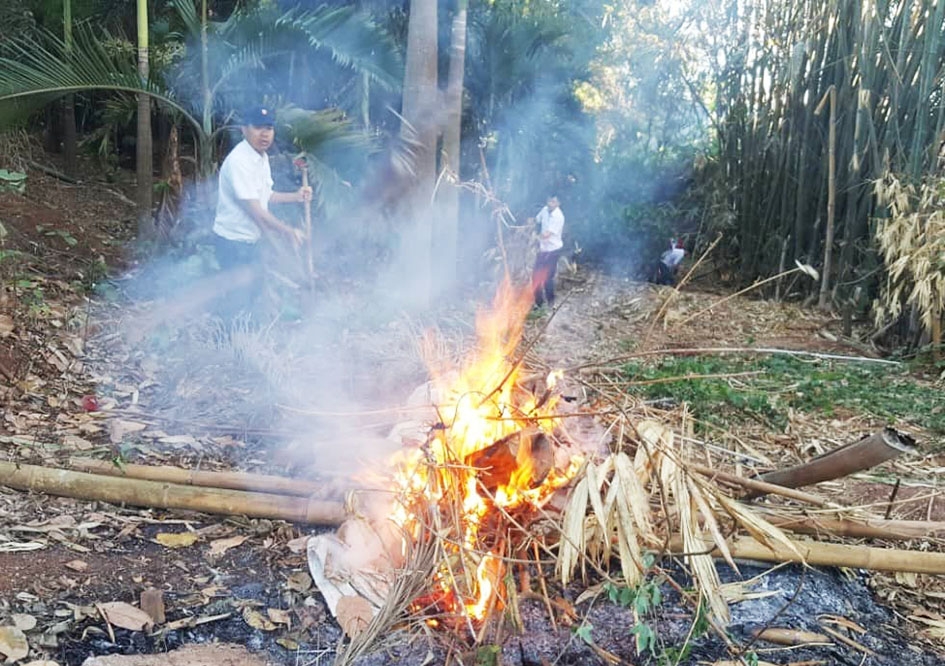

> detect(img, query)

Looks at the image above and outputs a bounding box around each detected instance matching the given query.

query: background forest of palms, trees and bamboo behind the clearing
[0,0,945,356]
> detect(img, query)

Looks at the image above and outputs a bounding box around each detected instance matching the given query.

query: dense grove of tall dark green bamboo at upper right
[701,0,945,348]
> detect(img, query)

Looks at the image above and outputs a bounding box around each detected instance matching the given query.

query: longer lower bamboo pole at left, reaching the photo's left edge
[0,462,345,525]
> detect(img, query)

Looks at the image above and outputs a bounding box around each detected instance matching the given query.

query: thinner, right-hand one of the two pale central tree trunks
[435,0,467,296]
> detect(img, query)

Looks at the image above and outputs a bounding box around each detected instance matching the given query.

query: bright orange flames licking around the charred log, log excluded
[392,282,580,620]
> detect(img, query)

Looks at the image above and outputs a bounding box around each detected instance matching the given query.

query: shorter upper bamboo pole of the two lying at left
[69,458,326,497]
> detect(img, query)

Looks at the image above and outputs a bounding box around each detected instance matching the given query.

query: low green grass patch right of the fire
[623,355,945,433]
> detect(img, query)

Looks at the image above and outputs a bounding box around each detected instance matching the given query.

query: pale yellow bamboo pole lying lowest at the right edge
[670,537,945,574]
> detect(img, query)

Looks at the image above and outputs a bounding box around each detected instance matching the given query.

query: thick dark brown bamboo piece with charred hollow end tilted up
[744,428,916,499]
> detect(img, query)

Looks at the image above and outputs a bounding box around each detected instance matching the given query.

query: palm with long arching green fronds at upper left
[0,0,401,202]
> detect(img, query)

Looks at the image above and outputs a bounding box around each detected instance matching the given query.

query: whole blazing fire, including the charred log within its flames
[393,284,581,625]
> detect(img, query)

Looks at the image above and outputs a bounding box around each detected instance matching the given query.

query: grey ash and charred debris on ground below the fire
[355,564,943,666]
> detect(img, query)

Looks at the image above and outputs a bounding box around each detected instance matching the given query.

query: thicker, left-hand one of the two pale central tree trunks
[401,0,439,307]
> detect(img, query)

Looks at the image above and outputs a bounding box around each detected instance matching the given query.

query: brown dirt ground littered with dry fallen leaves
[0,158,945,666]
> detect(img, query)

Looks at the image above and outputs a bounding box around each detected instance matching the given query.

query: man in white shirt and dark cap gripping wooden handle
[213,106,312,269]
